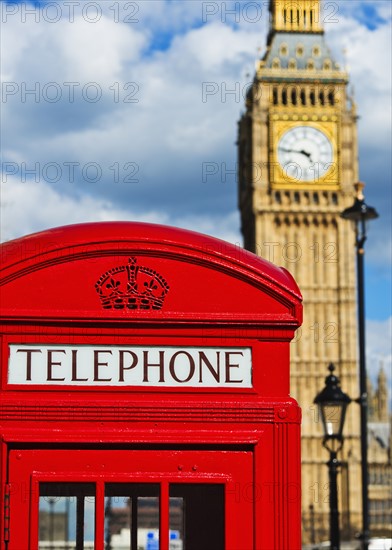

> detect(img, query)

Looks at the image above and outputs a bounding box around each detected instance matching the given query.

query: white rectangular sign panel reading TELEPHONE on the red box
[8,344,252,388]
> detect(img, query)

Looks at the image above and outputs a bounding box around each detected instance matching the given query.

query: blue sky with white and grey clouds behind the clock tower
[0,0,392,386]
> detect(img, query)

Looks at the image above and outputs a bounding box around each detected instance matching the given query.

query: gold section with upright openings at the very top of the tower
[270,0,323,32]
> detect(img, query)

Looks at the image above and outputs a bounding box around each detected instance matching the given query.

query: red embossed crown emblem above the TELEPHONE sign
[95,257,169,309]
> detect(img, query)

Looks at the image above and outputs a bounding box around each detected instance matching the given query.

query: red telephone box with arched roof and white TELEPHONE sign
[0,222,302,550]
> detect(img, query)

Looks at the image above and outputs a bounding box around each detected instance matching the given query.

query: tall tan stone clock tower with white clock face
[238,0,361,543]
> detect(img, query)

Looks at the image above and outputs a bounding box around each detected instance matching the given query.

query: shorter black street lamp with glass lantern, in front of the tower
[314,363,351,550]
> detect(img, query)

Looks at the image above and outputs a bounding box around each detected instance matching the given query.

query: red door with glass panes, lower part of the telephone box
[7,449,254,550]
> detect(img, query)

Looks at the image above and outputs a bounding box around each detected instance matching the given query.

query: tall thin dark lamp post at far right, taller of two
[340,183,378,550]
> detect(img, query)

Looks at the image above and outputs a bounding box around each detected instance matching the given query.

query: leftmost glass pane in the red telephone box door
[39,483,95,550]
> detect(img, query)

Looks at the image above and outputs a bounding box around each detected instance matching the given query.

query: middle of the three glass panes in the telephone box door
[105,483,159,550]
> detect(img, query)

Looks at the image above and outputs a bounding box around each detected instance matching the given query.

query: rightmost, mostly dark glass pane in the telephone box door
[169,483,225,550]
